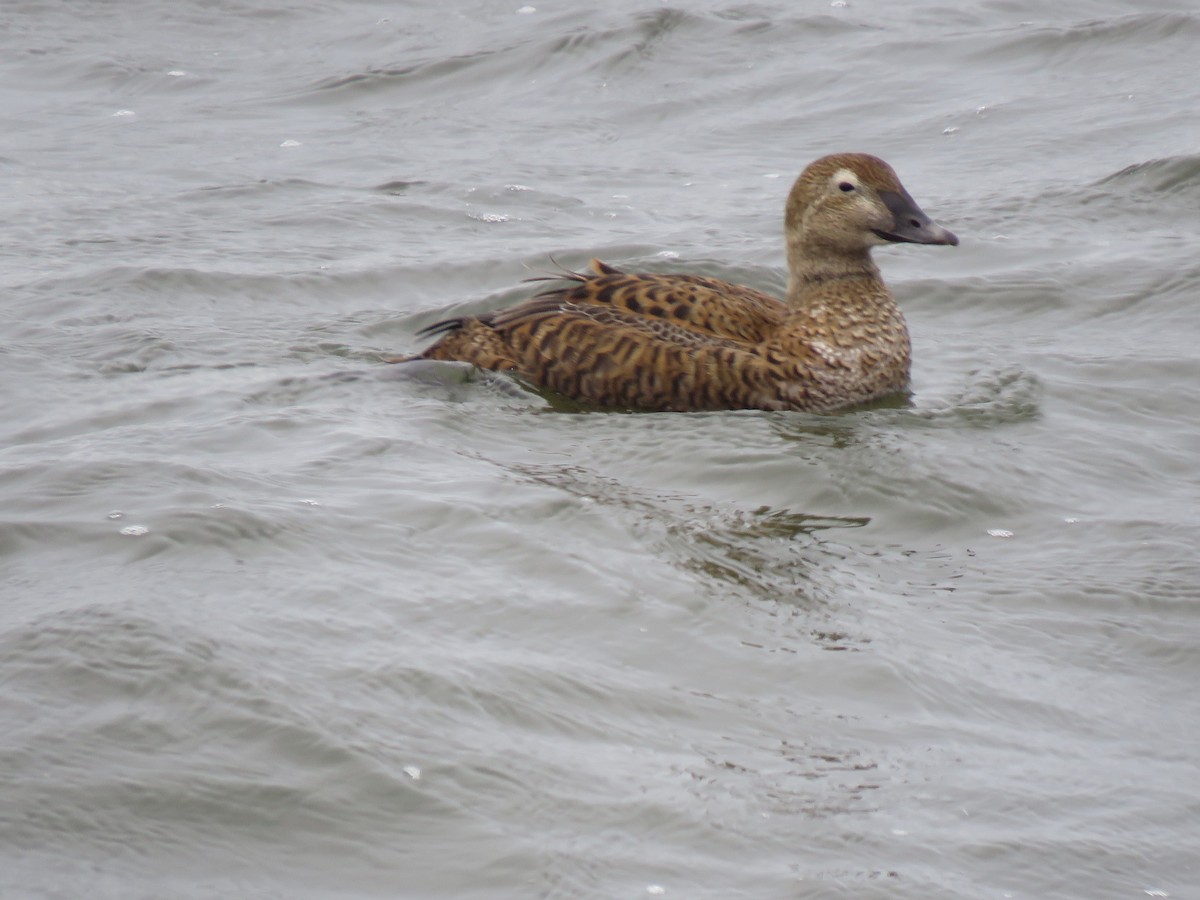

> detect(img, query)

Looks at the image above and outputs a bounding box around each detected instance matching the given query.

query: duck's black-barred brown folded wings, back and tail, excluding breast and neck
[403,262,808,410]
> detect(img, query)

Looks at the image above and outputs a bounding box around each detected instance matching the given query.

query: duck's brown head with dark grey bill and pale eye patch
[786,154,959,254]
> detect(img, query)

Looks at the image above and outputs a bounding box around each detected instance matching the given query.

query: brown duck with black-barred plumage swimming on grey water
[394,152,959,413]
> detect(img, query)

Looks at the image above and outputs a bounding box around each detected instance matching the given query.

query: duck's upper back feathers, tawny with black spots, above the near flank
[518,259,787,344]
